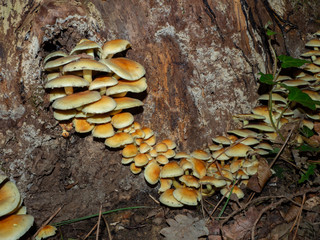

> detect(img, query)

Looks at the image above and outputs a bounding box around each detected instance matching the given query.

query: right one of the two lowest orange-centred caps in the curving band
[173,187,200,206]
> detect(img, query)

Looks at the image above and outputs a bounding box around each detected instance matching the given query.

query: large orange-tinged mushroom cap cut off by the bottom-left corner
[0,214,34,240]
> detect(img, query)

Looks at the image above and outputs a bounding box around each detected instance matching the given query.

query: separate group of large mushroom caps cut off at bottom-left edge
[0,174,34,240]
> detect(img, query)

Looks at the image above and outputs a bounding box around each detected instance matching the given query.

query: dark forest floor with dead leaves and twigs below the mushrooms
[25,160,320,240]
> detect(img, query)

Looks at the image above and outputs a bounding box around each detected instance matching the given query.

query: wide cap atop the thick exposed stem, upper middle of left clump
[62,58,110,74]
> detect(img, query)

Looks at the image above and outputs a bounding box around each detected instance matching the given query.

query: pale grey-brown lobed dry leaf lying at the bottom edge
[160,214,209,240]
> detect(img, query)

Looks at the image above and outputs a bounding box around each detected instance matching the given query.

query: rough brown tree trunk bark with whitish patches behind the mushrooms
[0,0,320,235]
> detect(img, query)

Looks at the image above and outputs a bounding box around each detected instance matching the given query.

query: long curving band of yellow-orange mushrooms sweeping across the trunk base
[44,29,320,210]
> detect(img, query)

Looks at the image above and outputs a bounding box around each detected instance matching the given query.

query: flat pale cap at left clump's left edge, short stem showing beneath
[44,75,89,88]
